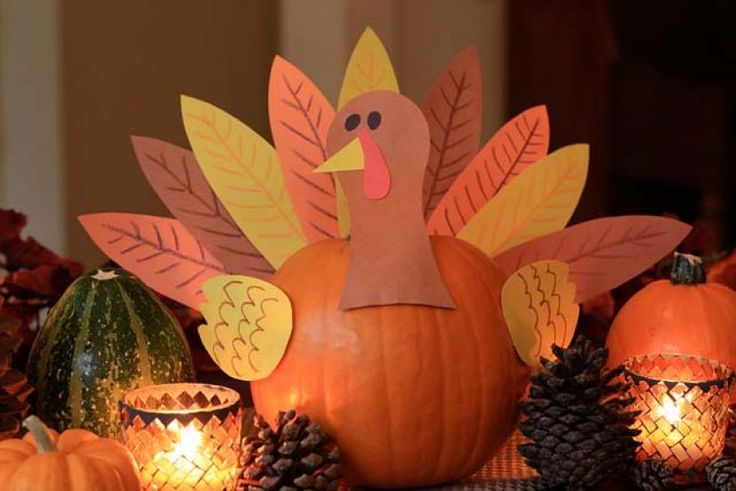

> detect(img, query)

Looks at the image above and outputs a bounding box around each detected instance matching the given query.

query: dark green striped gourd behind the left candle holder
[28,269,194,437]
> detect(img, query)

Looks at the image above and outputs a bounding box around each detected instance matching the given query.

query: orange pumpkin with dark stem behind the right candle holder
[606,253,736,367]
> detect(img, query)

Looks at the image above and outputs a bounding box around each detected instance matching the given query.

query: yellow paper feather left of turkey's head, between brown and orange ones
[181,96,306,268]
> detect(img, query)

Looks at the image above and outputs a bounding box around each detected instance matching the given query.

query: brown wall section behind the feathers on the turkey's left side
[62,0,278,265]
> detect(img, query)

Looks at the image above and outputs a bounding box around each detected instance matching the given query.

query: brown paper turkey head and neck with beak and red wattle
[317,91,455,309]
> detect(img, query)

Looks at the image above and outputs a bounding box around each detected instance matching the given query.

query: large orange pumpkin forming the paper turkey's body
[251,237,528,488]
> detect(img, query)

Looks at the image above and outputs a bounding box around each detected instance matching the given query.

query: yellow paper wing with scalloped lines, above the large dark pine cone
[501,260,580,367]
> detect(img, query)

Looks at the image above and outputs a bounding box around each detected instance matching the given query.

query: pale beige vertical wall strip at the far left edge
[0,0,66,251]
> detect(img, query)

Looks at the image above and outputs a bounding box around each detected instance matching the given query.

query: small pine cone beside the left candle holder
[243,409,342,491]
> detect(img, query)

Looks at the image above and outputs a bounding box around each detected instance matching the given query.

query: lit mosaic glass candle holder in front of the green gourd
[120,384,243,491]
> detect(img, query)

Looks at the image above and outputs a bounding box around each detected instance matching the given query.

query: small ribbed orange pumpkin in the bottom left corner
[0,416,141,491]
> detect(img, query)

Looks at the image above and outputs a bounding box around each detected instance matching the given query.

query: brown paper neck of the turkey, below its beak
[340,176,454,309]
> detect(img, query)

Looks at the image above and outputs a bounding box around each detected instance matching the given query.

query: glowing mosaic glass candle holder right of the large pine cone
[624,355,732,484]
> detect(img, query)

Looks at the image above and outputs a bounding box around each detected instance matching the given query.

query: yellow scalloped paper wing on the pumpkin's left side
[199,275,293,380]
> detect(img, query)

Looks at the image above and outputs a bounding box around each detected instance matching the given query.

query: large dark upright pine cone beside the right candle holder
[519,336,639,491]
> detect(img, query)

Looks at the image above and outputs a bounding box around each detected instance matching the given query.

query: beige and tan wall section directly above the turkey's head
[280,0,507,139]
